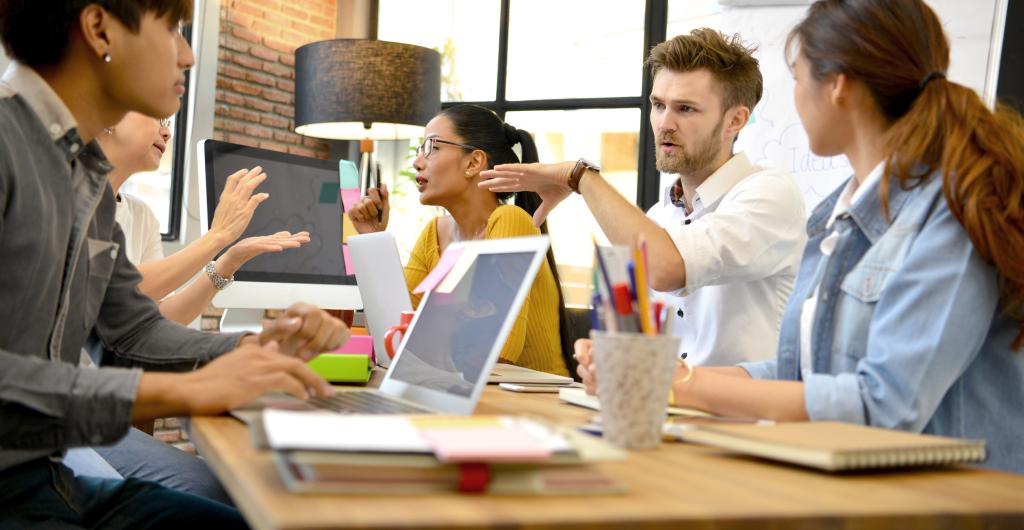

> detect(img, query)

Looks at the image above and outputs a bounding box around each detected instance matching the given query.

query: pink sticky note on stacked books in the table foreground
[420,427,551,462]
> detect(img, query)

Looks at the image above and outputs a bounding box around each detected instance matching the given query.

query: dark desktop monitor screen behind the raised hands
[203,140,355,284]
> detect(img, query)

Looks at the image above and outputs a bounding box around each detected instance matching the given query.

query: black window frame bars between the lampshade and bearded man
[432,0,669,211]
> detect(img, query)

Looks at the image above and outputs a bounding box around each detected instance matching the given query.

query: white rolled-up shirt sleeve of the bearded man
[667,172,806,296]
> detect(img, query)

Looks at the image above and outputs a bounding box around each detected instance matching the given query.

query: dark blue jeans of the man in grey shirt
[0,458,248,530]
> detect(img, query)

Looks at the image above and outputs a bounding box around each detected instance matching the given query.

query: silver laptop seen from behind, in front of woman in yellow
[348,232,413,367]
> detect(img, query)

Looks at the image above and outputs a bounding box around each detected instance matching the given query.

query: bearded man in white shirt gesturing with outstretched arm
[480,28,806,376]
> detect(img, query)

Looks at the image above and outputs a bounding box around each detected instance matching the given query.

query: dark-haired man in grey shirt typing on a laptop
[0,0,348,529]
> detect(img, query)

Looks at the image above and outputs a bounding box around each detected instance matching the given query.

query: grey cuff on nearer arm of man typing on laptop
[65,368,142,445]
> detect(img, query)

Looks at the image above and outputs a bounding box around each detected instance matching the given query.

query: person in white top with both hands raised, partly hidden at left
[96,113,309,324]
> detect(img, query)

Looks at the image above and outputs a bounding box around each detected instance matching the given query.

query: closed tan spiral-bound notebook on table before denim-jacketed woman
[678,422,985,472]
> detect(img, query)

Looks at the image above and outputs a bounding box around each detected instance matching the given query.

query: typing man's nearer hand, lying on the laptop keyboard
[171,341,334,415]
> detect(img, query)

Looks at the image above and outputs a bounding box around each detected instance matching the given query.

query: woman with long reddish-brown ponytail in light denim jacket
[584,0,1024,473]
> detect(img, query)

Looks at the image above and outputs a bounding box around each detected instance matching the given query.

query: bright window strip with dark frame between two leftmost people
[121,26,191,241]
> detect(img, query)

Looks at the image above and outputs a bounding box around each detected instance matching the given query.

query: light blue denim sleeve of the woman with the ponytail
[804,203,998,432]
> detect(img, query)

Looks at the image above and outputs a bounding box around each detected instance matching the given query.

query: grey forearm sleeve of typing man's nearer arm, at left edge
[0,351,142,450]
